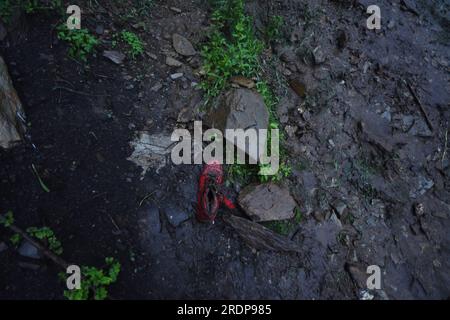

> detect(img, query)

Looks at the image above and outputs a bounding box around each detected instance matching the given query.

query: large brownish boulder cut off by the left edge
[0,57,25,149]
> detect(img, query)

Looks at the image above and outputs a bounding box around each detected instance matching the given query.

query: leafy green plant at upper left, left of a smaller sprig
[57,24,98,61]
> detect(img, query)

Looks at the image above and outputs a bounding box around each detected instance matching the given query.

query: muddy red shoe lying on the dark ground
[196,161,235,222]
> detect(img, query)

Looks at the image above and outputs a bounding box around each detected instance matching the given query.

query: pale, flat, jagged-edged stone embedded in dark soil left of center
[127,132,175,179]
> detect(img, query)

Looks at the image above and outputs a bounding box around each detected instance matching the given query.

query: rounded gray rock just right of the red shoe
[238,183,297,222]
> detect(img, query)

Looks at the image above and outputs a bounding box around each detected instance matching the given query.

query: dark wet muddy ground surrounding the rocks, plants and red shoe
[0,0,450,299]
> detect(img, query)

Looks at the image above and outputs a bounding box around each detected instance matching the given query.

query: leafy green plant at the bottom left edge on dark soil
[61,257,120,300]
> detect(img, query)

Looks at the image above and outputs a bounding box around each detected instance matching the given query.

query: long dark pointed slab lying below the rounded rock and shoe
[223,215,301,253]
